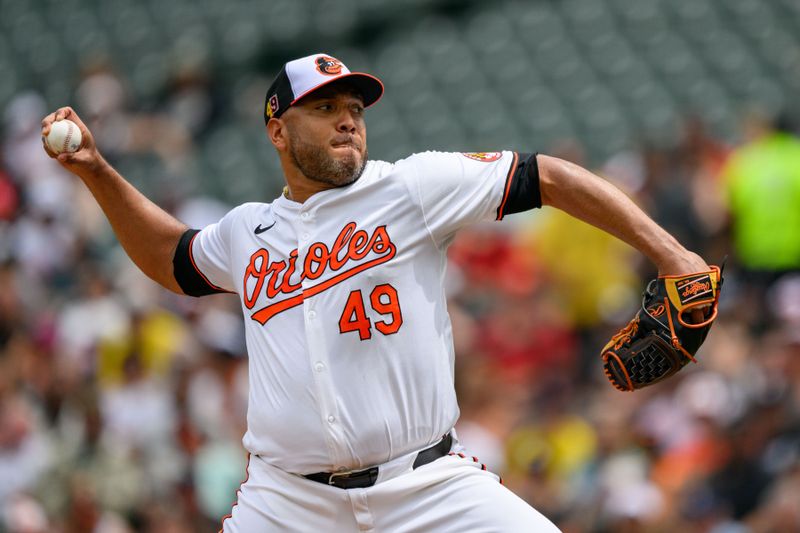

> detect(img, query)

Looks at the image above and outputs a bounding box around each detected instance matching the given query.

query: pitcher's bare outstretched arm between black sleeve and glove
[537,155,707,274]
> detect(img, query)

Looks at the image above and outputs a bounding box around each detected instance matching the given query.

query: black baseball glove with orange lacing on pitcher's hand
[601,266,722,391]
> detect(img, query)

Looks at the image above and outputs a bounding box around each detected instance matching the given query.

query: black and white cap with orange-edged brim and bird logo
[264,54,383,122]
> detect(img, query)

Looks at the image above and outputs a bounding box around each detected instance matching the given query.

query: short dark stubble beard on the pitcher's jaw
[289,128,368,187]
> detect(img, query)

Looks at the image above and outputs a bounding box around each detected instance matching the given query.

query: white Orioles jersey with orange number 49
[181,152,540,474]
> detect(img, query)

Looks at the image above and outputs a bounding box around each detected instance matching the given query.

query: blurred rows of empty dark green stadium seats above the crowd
[6,0,800,172]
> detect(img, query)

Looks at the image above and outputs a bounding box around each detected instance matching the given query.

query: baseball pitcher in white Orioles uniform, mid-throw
[42,54,719,533]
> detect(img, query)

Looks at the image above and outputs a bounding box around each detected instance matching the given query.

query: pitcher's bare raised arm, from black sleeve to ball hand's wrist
[77,157,187,293]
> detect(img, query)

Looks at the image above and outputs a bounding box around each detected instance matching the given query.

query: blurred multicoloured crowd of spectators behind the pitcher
[0,64,800,533]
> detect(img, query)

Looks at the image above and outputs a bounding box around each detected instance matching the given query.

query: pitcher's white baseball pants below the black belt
[216,446,559,533]
